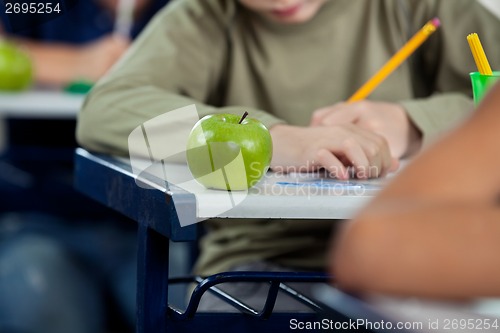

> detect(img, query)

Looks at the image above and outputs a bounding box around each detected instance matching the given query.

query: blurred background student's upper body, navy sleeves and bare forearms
[0,0,168,85]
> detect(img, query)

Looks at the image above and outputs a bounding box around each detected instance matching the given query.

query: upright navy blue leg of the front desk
[136,224,169,333]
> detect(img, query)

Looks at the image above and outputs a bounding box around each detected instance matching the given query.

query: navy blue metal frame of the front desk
[75,148,354,333]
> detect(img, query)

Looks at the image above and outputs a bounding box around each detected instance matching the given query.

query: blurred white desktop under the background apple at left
[0,91,85,119]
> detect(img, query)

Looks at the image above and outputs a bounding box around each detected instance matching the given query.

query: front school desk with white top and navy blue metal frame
[75,149,382,333]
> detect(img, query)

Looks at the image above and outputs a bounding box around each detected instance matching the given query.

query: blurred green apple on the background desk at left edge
[0,40,33,91]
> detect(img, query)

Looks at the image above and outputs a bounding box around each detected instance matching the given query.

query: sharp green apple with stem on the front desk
[186,112,273,191]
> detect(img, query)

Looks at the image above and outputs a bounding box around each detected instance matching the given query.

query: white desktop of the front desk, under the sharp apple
[126,159,394,224]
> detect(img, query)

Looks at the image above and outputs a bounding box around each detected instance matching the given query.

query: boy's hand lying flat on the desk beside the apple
[271,124,397,179]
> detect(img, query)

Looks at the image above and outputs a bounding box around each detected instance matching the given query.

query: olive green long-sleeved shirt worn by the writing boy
[77,0,500,274]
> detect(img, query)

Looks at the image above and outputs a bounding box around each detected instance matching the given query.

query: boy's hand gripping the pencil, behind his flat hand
[311,101,421,158]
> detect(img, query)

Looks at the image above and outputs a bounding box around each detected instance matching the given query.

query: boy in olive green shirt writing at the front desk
[77,0,500,307]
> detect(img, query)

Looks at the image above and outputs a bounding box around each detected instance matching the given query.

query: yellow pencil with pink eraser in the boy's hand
[348,18,441,103]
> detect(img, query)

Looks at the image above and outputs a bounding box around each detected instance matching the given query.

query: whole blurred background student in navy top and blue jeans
[0,0,168,333]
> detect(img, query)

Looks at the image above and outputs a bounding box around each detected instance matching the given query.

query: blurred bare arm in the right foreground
[331,86,500,298]
